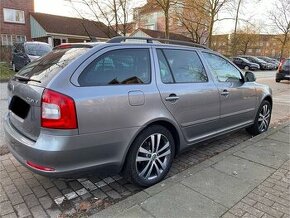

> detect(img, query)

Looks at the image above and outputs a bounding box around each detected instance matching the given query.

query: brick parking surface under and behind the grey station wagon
[0,131,250,217]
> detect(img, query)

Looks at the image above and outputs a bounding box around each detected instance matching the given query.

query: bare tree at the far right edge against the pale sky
[269,0,290,59]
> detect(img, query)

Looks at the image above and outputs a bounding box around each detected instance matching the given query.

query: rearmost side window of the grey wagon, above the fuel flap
[78,49,151,86]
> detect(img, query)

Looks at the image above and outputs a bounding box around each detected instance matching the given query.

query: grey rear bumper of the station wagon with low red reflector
[4,113,137,178]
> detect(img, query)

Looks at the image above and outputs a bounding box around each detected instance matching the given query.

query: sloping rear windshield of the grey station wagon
[16,48,89,85]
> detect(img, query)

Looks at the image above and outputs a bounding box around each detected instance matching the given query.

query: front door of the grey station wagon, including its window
[202,51,257,130]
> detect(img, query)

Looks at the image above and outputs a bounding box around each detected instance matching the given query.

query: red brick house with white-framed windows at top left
[0,0,34,60]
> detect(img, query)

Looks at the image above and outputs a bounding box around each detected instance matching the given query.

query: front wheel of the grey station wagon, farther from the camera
[246,100,272,136]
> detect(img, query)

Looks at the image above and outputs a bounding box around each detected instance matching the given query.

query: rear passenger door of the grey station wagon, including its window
[155,48,220,143]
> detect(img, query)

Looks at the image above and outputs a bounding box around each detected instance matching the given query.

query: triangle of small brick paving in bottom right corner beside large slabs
[222,160,290,218]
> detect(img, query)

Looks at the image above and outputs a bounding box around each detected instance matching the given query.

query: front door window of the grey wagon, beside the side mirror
[203,52,242,82]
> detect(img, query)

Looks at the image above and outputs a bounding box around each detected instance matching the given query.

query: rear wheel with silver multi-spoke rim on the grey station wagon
[124,125,175,187]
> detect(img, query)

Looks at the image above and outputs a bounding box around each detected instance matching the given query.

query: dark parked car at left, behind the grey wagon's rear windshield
[12,42,52,72]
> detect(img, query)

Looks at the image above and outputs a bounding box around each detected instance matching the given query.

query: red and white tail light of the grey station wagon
[41,89,78,129]
